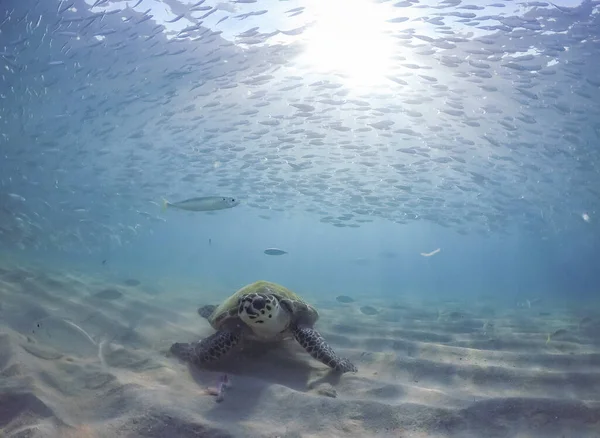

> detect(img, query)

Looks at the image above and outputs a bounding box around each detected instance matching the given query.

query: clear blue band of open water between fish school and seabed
[9,206,600,304]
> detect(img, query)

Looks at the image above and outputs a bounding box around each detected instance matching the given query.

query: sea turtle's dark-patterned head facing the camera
[238,293,289,335]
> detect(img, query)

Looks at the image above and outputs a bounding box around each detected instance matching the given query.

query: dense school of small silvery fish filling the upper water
[0,0,600,251]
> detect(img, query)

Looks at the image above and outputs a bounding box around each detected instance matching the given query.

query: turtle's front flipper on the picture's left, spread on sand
[171,331,241,366]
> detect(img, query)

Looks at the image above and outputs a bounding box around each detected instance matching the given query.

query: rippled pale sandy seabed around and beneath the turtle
[0,263,600,438]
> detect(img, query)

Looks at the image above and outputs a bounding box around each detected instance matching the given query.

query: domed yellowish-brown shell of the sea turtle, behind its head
[208,280,319,330]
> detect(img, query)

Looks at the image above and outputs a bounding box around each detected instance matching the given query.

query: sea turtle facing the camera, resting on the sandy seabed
[171,281,357,373]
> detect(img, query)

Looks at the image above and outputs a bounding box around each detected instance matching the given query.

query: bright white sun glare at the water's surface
[302,0,394,86]
